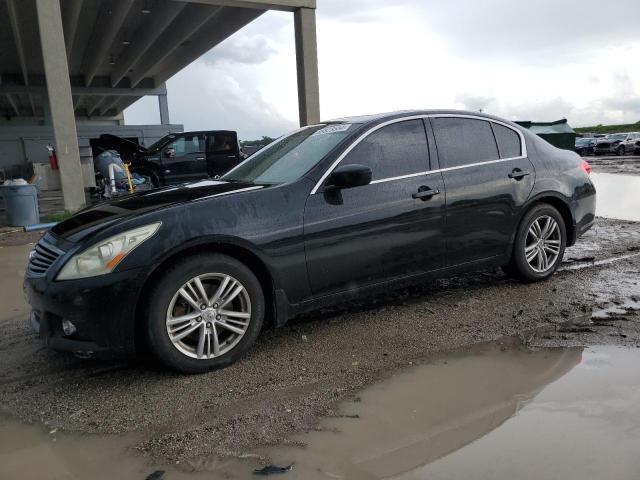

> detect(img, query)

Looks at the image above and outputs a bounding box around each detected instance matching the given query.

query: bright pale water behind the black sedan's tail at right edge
[591,173,640,221]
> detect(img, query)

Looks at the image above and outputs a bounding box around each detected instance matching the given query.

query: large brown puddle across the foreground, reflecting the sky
[0,344,640,480]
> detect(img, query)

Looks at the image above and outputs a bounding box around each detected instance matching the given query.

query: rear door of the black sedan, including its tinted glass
[431,115,535,266]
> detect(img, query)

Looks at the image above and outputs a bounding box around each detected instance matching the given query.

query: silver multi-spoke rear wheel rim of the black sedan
[524,215,562,273]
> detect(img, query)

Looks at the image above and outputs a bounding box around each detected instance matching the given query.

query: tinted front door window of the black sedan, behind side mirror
[341,120,429,180]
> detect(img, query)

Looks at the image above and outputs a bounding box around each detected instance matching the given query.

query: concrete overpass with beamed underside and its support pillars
[0,0,320,211]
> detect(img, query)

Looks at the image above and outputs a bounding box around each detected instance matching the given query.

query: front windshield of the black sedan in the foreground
[221,123,353,183]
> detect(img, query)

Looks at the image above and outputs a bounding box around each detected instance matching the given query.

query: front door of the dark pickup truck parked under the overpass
[162,133,207,183]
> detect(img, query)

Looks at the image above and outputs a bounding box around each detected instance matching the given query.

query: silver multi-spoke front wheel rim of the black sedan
[166,273,251,360]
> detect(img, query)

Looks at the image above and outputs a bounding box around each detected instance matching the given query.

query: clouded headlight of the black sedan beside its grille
[56,222,162,280]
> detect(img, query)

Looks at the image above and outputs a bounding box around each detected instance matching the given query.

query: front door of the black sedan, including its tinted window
[304,119,445,295]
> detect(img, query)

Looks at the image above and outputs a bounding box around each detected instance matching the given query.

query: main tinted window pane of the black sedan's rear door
[432,117,500,168]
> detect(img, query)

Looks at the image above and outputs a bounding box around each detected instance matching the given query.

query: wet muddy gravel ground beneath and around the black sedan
[0,218,640,469]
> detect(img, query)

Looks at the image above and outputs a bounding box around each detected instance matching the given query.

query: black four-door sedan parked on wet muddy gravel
[24,111,596,372]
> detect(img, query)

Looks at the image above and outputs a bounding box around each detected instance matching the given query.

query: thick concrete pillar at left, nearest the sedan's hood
[36,0,85,212]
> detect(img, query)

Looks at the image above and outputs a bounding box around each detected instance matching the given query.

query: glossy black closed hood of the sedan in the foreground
[51,180,267,242]
